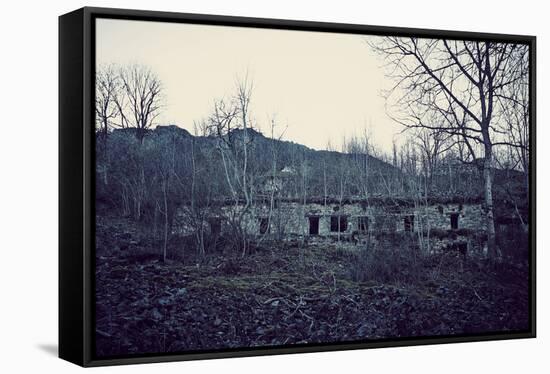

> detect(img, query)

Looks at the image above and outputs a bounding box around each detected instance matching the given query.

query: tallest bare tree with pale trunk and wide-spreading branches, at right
[370,37,527,258]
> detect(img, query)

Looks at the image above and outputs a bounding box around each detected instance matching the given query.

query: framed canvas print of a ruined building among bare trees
[59,8,535,366]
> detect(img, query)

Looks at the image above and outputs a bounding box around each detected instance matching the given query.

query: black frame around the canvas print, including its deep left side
[59,7,536,366]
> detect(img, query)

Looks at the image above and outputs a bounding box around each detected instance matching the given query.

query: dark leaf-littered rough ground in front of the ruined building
[96,218,529,357]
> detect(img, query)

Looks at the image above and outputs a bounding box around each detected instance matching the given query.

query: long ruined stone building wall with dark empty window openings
[172,202,492,253]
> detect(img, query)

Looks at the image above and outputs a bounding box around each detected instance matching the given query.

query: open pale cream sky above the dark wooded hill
[96,19,401,151]
